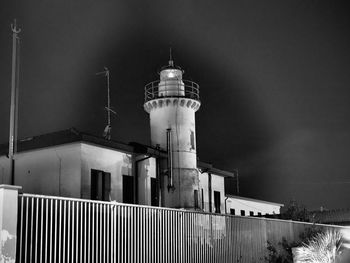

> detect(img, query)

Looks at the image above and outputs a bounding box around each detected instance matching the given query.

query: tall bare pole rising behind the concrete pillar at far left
[8,19,21,185]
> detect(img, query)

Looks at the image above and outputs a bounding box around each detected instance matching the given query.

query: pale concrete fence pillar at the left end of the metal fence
[0,184,22,263]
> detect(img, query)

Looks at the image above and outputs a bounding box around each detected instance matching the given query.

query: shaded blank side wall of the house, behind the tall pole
[0,143,81,197]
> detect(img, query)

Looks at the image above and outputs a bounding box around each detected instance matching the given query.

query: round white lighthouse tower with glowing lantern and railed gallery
[144,55,200,209]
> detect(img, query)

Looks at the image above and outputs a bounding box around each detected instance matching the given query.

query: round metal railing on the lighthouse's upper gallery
[145,80,199,102]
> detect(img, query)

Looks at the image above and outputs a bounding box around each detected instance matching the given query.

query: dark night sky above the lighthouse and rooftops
[0,0,350,209]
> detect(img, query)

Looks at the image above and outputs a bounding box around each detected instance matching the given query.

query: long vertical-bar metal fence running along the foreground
[17,194,342,263]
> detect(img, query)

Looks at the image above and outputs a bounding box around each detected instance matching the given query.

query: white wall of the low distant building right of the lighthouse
[226,197,281,216]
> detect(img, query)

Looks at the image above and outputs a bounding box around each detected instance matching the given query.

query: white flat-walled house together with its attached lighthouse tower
[0,59,282,217]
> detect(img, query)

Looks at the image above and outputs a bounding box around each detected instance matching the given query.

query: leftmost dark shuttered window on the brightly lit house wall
[91,169,111,201]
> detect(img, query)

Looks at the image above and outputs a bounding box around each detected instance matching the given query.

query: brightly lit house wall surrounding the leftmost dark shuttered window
[81,143,133,202]
